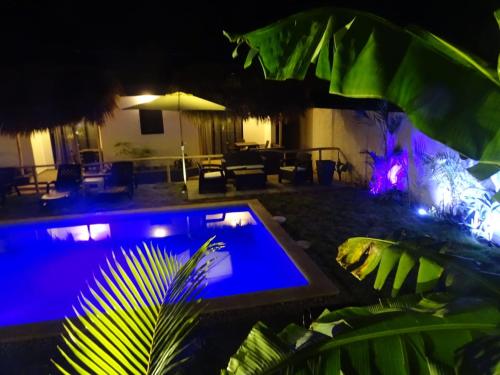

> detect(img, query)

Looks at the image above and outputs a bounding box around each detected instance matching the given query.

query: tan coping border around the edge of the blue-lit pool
[0,199,339,343]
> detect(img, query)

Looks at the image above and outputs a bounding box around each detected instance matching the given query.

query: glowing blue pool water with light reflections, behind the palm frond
[0,205,307,326]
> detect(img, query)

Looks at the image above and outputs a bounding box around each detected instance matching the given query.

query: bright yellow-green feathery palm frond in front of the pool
[53,238,220,375]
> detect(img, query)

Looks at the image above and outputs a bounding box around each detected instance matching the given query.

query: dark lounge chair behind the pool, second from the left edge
[40,164,82,207]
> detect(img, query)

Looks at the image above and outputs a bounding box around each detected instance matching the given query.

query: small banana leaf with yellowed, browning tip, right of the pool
[337,237,500,298]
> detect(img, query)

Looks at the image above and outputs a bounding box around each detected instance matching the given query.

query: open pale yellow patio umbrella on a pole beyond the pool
[124,91,226,184]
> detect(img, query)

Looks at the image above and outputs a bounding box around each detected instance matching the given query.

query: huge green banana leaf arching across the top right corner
[225,7,500,177]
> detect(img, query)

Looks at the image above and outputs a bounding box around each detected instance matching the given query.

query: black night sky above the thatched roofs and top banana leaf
[0,0,500,89]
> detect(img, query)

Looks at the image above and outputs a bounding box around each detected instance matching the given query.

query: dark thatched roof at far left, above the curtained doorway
[0,63,120,134]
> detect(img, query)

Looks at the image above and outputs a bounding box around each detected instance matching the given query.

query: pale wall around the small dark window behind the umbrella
[101,97,200,161]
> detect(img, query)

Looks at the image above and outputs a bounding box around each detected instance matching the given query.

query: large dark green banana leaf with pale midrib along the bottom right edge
[222,296,500,375]
